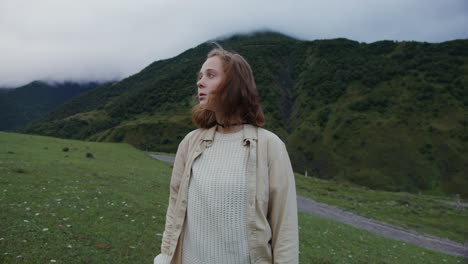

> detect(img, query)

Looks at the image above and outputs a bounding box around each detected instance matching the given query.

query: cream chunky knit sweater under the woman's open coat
[182,131,250,264]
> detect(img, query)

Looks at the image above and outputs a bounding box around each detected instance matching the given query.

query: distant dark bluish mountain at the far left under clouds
[0,81,98,131]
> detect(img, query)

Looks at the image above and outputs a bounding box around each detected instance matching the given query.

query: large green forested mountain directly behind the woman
[23,32,468,196]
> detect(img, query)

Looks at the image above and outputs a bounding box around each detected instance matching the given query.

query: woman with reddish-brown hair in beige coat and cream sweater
[154,47,299,264]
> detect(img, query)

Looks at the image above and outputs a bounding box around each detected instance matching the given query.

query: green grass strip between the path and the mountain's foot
[296,174,468,243]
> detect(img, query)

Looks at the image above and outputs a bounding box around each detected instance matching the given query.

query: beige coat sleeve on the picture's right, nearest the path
[267,141,299,264]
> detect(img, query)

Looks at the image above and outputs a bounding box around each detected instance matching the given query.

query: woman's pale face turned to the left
[197,56,225,105]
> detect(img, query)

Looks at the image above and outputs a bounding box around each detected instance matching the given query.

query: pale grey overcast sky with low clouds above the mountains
[0,0,468,87]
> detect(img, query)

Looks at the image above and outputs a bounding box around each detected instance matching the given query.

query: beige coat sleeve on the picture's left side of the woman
[154,136,189,264]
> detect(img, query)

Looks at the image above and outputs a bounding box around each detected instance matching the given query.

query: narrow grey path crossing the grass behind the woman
[150,154,468,258]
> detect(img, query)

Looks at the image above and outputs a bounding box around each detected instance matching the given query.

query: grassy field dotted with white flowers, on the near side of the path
[0,132,466,264]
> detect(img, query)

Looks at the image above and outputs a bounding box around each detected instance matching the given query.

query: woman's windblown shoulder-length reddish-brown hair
[192,45,265,128]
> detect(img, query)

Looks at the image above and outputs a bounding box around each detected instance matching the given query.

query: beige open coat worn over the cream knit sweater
[155,125,299,264]
